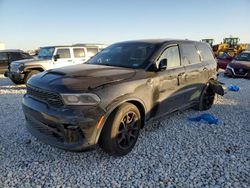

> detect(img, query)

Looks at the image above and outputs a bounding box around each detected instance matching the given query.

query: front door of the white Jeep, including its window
[53,47,73,68]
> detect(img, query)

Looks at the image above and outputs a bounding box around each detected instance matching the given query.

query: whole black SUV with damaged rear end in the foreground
[23,40,224,156]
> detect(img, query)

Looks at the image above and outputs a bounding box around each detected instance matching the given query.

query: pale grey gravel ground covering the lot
[0,72,250,187]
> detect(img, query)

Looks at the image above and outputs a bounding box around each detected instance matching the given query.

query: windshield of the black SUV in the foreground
[88,43,155,69]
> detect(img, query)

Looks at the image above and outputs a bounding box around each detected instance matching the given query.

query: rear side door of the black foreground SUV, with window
[180,43,208,102]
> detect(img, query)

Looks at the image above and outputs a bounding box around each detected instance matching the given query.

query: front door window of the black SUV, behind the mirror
[159,46,181,68]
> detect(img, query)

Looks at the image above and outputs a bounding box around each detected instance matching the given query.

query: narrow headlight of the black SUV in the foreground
[61,93,100,105]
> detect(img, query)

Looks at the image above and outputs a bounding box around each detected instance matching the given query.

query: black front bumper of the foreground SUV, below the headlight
[22,95,104,151]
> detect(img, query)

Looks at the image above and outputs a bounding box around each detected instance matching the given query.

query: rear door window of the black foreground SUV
[181,44,201,65]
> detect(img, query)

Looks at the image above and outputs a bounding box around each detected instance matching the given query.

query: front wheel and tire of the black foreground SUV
[99,103,142,156]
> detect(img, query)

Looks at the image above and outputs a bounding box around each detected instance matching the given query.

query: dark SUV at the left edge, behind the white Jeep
[0,50,32,76]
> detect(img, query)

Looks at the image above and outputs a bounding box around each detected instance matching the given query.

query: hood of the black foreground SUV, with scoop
[28,64,136,93]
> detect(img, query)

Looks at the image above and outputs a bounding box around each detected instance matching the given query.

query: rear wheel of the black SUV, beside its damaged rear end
[194,84,215,111]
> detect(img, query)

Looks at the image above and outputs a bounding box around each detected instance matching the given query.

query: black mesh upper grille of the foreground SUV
[27,86,63,108]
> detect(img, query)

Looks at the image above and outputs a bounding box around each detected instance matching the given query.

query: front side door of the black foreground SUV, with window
[155,45,186,115]
